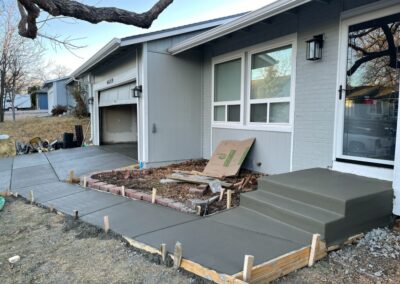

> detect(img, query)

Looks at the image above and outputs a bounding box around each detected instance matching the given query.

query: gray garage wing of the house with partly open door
[67,15,244,162]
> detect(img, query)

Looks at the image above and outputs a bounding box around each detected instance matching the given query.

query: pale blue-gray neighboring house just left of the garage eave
[42,77,75,113]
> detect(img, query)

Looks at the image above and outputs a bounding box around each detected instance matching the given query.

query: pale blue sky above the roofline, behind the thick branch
[41,0,274,74]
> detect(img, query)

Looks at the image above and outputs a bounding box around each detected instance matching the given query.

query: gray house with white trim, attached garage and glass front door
[73,0,400,215]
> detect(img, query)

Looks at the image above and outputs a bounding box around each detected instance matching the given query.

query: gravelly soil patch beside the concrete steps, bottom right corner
[275,228,400,284]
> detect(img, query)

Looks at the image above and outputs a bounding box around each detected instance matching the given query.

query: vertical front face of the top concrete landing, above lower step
[258,177,346,215]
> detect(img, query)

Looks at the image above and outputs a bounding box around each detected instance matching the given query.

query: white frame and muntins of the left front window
[211,52,245,127]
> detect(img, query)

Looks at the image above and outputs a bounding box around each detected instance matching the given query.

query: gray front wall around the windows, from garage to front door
[202,0,382,173]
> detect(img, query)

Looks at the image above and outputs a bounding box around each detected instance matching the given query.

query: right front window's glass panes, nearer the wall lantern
[249,45,292,124]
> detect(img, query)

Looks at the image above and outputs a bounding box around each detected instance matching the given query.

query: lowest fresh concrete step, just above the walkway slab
[240,190,344,237]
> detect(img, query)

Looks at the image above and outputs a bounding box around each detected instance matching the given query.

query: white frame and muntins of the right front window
[246,35,297,130]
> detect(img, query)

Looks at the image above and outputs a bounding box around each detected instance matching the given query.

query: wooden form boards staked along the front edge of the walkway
[124,237,327,284]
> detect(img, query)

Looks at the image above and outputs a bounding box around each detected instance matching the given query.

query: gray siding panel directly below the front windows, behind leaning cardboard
[212,128,291,174]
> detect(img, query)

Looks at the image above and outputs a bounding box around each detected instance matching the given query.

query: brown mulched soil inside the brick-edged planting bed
[92,160,261,214]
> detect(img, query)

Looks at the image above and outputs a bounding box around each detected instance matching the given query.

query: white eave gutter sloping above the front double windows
[168,0,313,55]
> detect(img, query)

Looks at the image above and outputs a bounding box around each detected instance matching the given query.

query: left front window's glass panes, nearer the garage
[213,58,243,123]
